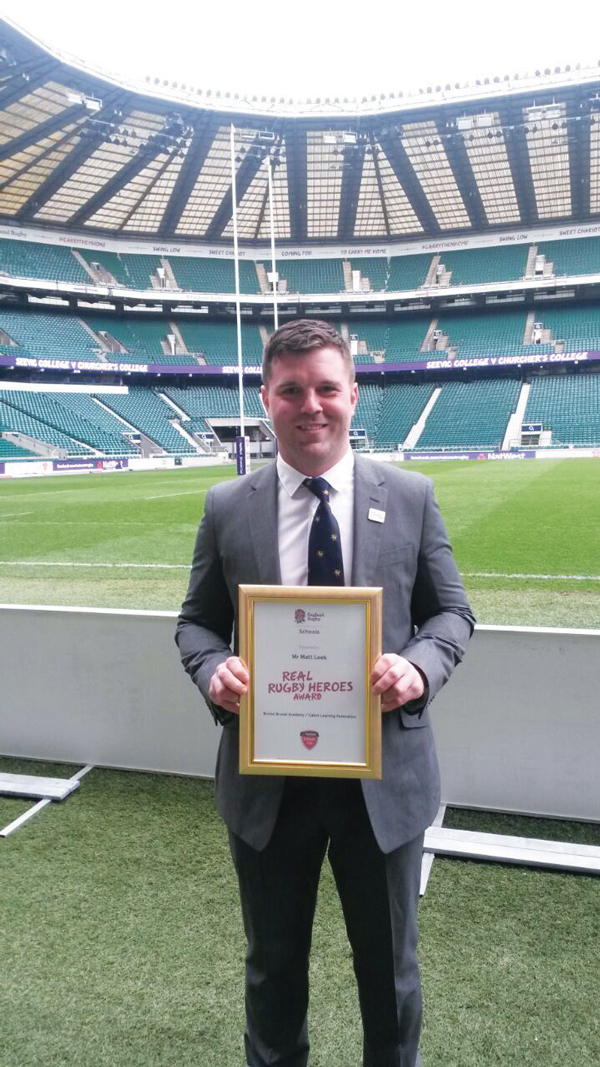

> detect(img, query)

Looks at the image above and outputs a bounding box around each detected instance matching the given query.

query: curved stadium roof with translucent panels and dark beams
[0,20,600,244]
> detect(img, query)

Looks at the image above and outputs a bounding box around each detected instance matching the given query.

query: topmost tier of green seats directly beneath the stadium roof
[0,237,600,299]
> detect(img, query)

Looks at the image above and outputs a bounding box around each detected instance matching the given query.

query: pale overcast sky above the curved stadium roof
[2,0,600,99]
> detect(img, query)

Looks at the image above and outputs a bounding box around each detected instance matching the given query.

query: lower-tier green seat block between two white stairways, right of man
[416,378,521,450]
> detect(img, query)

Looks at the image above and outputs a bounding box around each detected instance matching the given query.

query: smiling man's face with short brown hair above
[262,348,358,478]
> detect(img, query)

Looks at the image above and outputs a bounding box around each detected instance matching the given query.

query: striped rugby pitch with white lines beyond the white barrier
[0,459,600,628]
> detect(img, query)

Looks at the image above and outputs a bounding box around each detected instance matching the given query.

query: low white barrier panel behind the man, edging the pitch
[0,606,600,821]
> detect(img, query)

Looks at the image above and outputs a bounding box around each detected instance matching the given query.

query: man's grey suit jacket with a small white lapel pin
[176,456,474,853]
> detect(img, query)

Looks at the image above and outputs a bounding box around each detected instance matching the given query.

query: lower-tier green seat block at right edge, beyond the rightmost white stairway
[523,375,600,446]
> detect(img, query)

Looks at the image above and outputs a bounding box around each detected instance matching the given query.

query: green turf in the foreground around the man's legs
[0,759,600,1067]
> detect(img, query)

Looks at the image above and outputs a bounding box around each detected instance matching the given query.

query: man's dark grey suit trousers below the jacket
[230,779,423,1067]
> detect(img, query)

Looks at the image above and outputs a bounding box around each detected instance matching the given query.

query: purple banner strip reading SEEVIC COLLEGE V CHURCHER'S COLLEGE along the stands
[0,350,600,378]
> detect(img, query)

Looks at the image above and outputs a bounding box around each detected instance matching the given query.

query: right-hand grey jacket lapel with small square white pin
[352,456,388,586]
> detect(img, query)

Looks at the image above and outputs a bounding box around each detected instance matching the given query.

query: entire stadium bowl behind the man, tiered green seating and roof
[0,20,600,469]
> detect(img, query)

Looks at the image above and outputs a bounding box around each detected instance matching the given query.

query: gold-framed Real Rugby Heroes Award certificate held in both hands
[239,586,382,778]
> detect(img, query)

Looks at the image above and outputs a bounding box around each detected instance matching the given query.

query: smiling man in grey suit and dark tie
[177,319,474,1067]
